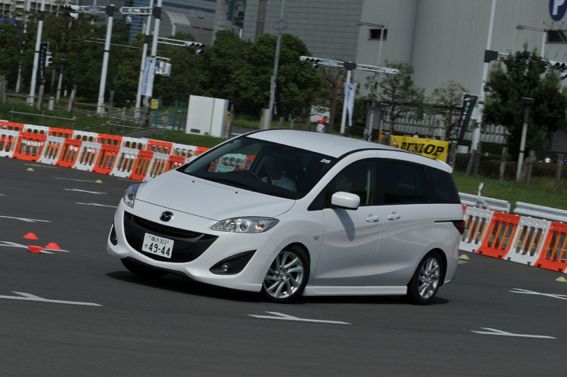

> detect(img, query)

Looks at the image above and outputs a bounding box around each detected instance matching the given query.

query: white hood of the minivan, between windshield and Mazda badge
[136,170,294,221]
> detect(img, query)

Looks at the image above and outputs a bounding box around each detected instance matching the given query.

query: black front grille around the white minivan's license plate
[124,212,217,263]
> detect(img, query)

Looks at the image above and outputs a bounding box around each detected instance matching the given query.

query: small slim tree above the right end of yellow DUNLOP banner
[431,80,466,140]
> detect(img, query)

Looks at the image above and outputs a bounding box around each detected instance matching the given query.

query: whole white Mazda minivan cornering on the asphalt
[108,130,464,304]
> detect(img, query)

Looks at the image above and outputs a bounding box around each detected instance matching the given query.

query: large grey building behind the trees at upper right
[243,0,567,94]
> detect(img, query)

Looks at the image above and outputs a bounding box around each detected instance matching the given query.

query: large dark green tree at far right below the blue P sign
[484,47,567,153]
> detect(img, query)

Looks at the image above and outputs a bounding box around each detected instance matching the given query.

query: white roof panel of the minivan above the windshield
[247,129,399,158]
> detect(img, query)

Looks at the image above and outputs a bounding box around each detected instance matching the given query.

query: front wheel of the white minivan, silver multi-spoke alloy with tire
[262,248,309,302]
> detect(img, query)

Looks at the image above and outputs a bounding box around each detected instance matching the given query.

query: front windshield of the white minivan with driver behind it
[179,136,336,199]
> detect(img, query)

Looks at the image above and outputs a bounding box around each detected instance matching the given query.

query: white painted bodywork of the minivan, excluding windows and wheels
[107,130,463,295]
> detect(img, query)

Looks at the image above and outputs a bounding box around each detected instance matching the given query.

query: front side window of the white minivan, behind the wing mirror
[325,159,376,207]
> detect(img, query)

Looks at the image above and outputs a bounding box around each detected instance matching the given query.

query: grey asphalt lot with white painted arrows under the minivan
[0,154,567,377]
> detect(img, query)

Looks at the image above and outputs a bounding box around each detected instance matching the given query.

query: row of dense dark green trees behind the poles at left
[0,14,320,117]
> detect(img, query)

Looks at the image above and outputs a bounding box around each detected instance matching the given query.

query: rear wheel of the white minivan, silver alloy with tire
[407,252,443,305]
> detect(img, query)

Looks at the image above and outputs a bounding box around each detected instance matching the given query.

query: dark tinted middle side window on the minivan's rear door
[376,159,427,204]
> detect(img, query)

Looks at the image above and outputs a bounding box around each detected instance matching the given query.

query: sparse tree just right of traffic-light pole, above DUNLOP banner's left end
[365,62,424,132]
